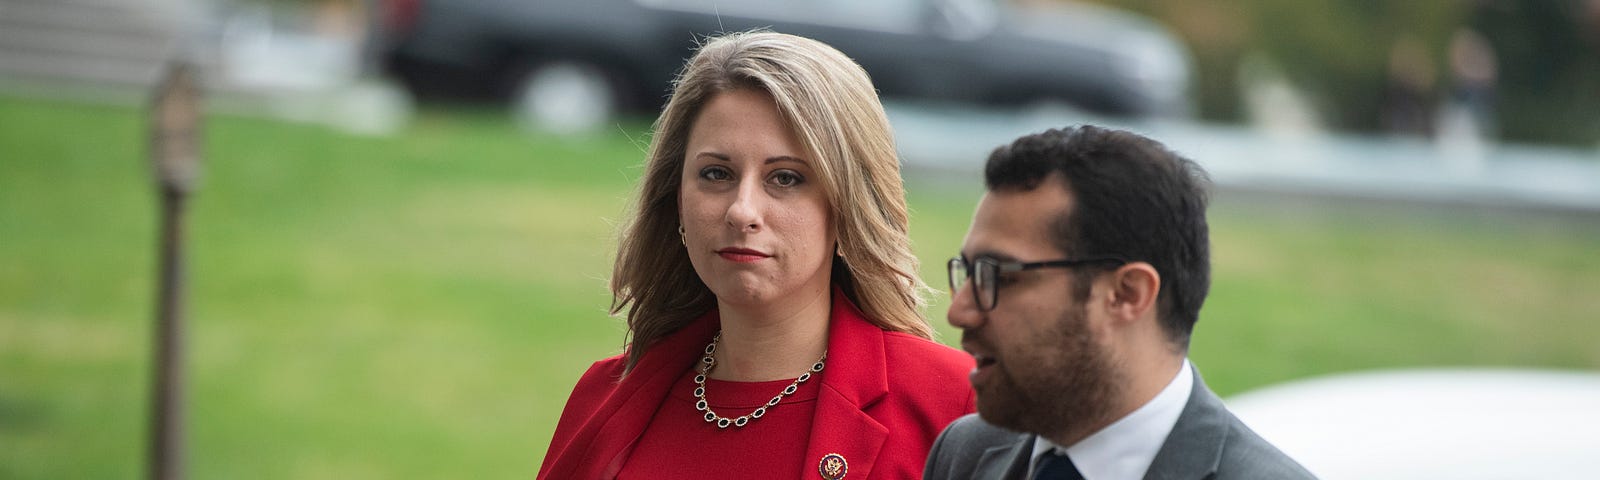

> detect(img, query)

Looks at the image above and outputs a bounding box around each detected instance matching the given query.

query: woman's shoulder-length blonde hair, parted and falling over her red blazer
[611,30,933,371]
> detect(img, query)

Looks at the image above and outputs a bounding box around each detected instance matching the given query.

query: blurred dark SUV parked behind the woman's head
[378,0,1189,130]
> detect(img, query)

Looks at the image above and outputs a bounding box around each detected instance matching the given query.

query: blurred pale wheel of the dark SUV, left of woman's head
[512,61,622,134]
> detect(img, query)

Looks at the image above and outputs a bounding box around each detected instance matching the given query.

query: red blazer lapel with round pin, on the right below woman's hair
[800,286,890,478]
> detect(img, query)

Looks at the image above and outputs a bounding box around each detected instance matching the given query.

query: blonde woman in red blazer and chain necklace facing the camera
[539,32,973,478]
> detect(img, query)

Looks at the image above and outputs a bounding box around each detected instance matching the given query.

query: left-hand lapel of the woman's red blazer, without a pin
[569,310,722,478]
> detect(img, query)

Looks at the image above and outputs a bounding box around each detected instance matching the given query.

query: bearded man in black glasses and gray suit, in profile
[923,126,1314,480]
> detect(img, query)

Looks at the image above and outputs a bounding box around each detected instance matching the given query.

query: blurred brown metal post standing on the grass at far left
[149,62,202,480]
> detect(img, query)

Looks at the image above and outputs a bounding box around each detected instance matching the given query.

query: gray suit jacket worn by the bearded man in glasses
[923,366,1315,480]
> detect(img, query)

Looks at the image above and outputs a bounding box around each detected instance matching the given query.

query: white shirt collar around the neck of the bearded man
[1027,358,1195,480]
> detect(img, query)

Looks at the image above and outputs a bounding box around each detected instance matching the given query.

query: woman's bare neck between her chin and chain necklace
[710,288,834,382]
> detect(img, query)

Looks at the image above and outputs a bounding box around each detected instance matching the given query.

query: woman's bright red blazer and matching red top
[538,290,974,480]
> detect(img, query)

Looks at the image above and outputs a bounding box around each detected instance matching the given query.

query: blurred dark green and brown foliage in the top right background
[1081,0,1600,146]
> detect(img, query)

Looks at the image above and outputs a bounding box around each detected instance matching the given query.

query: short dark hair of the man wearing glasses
[984,126,1211,349]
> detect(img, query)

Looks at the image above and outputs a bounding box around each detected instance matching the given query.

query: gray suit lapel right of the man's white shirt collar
[1144,365,1229,480]
